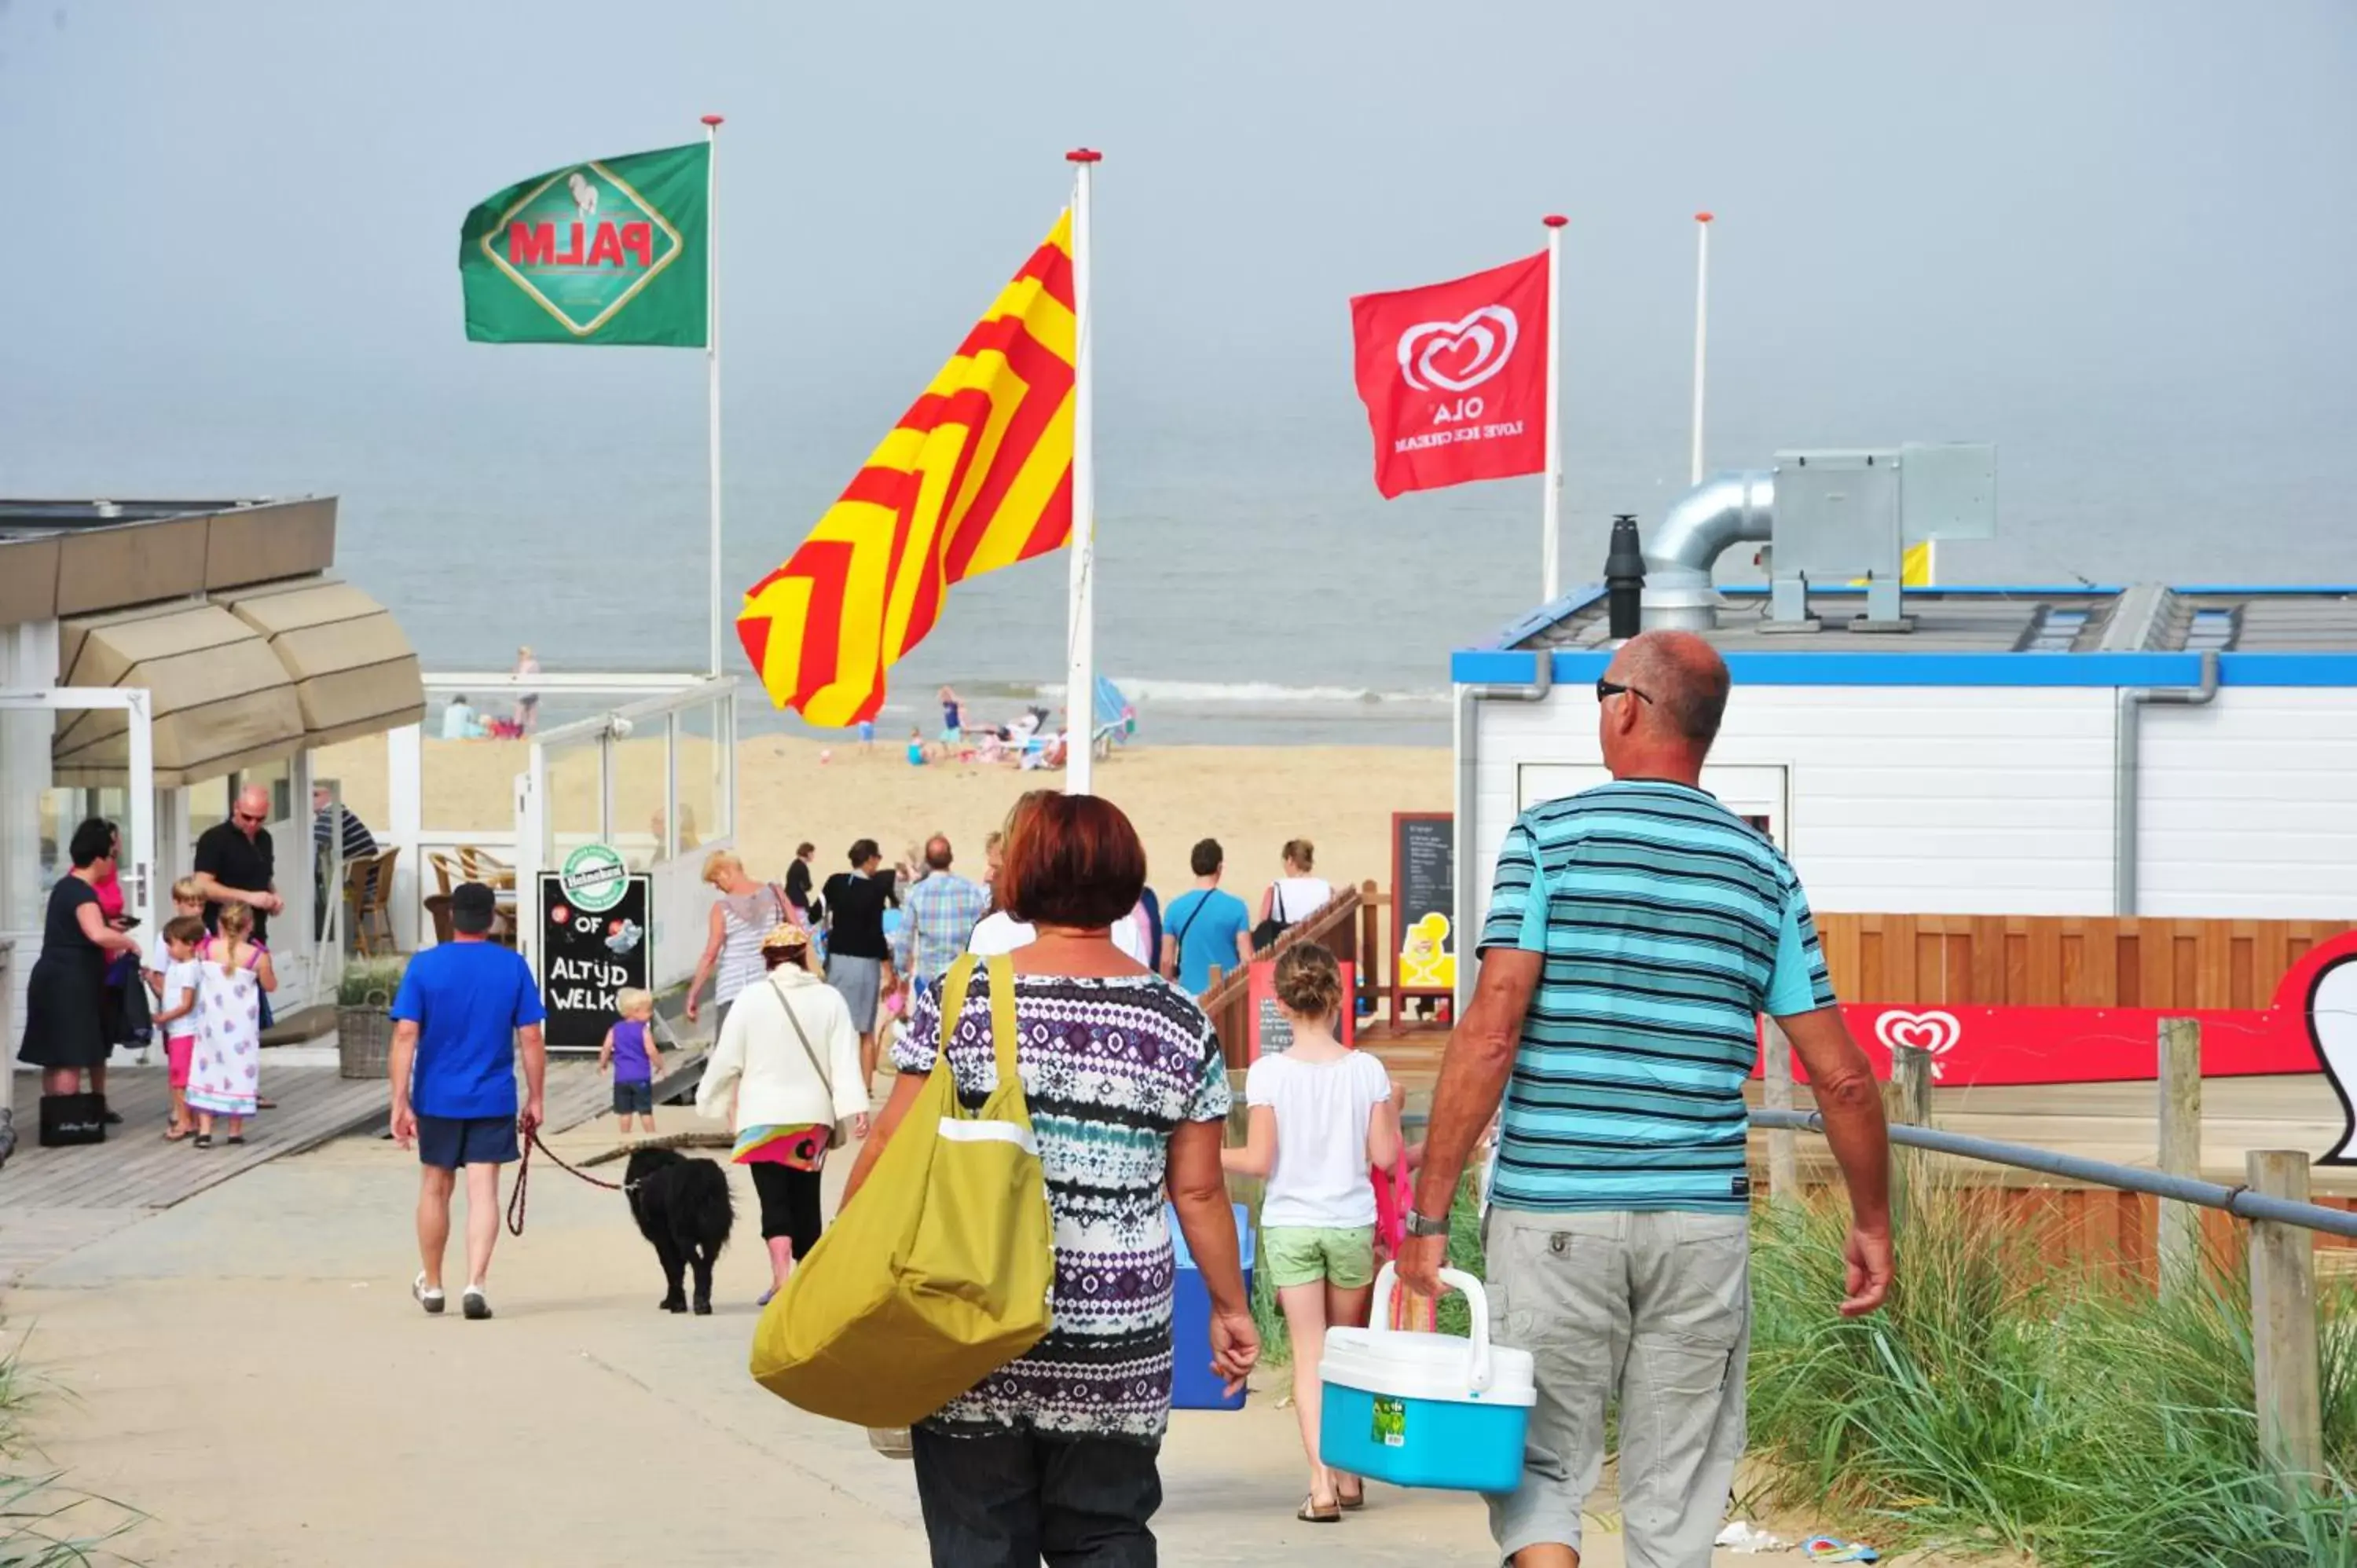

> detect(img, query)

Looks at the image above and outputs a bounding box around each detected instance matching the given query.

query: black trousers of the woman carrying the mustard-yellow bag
[910,1427,1162,1568]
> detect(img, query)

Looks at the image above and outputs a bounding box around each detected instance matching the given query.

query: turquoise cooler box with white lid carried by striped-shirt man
[1318,1264,1539,1493]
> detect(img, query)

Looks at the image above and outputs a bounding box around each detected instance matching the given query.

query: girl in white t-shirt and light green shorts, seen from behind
[1221,943,1400,1523]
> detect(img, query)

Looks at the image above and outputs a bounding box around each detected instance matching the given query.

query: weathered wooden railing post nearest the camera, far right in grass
[2246,1149,2324,1495]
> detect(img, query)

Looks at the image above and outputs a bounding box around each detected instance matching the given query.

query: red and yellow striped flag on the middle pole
[738,212,1077,726]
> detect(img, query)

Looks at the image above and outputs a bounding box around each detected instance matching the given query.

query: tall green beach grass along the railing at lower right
[1749,1189,2357,1568]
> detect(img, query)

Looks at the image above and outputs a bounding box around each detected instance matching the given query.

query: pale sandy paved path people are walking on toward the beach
[0,1111,1876,1568]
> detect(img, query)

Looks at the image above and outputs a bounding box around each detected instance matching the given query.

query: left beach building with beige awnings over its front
[0,497,424,1057]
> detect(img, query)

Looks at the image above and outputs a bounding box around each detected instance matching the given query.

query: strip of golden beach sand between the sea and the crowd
[318,735,1450,903]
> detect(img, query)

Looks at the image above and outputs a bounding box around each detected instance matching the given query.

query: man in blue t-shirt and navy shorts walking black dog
[391,882,549,1318]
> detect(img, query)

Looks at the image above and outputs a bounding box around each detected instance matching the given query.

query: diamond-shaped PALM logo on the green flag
[481,163,681,337]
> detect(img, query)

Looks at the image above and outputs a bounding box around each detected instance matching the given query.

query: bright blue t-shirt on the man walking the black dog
[394,941,547,1118]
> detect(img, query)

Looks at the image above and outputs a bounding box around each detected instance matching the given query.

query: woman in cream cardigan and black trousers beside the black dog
[695,925,867,1306]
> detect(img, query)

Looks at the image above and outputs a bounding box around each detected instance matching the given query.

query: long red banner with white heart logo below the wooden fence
[1794,932,2357,1101]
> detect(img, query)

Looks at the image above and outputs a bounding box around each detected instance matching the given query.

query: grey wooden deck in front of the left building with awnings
[0,1057,646,1285]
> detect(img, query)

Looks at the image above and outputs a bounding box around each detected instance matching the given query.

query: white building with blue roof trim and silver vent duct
[1450,460,2357,995]
